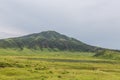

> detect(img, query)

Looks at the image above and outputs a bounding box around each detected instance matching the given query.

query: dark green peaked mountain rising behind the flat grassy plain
[0,31,102,52]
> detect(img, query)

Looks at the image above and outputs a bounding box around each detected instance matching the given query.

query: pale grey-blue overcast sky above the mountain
[0,0,120,49]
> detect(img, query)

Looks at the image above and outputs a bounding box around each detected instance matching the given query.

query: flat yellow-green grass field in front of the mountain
[0,49,120,80]
